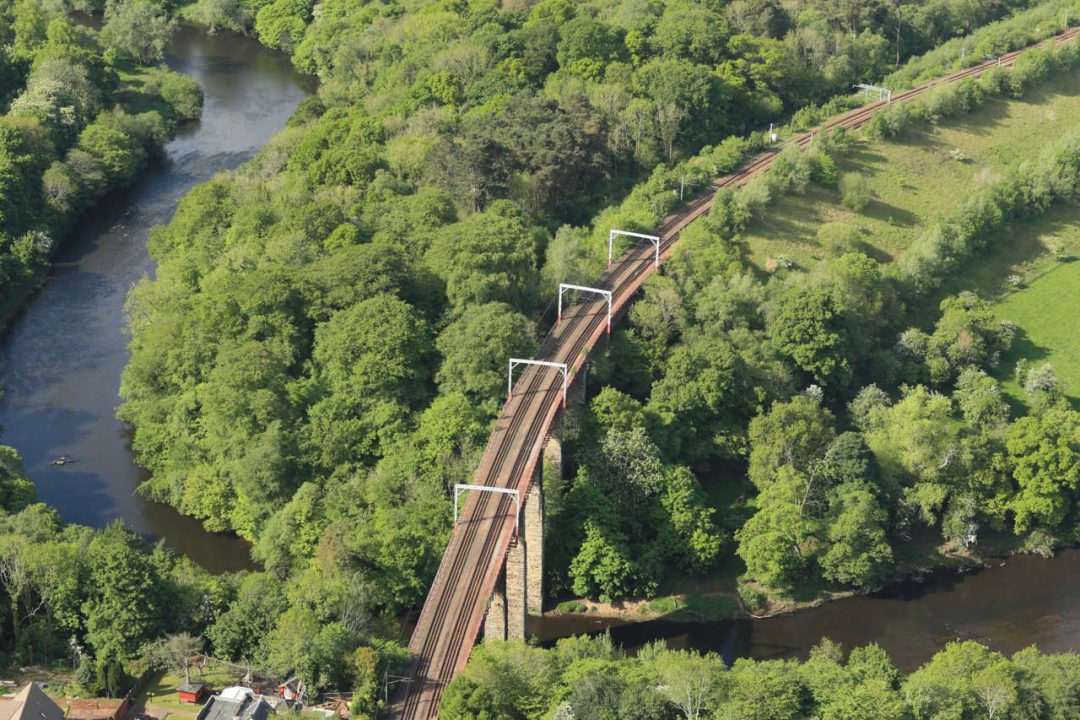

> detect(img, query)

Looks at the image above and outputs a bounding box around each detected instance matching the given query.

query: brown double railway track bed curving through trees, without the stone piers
[392,28,1080,720]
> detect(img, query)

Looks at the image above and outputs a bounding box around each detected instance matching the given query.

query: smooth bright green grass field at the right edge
[995,261,1080,403]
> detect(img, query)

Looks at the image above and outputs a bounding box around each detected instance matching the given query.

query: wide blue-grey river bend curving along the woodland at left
[0,27,311,571]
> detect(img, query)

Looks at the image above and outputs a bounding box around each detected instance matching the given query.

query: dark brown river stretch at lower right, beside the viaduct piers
[530,549,1080,671]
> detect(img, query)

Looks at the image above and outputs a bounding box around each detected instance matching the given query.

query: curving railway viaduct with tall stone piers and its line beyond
[391,28,1080,720]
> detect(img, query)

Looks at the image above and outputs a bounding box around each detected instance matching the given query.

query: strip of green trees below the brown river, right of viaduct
[438,636,1080,720]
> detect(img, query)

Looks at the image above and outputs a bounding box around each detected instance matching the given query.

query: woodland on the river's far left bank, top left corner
[0,0,202,320]
